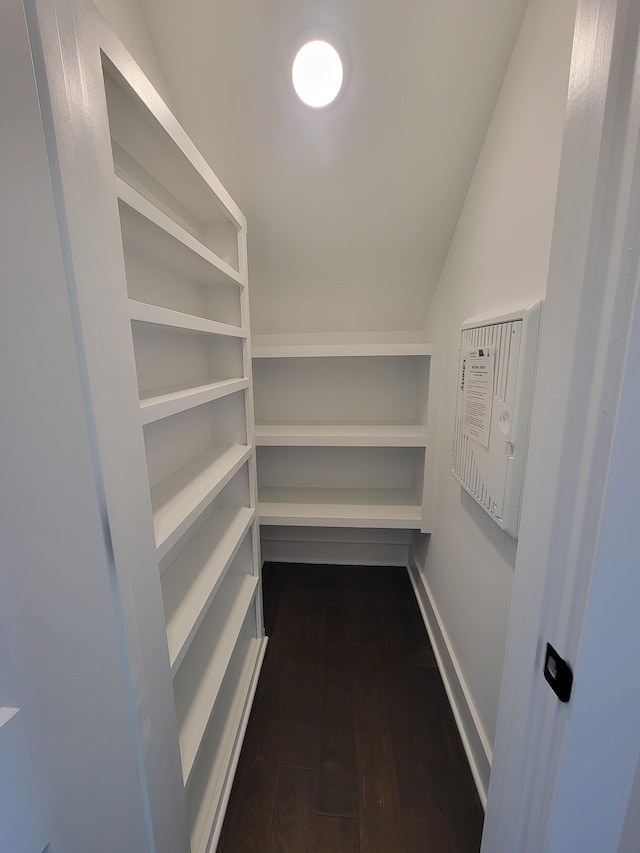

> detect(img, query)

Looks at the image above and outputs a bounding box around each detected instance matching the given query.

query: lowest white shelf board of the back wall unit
[258,488,422,530]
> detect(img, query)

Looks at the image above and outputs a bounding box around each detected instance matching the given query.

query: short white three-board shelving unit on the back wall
[253,332,434,532]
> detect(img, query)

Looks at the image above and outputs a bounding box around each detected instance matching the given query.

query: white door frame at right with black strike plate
[482,0,640,853]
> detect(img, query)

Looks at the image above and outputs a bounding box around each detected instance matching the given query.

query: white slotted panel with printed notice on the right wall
[451,302,541,538]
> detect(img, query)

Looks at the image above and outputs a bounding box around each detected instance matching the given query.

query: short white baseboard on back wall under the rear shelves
[261,539,409,567]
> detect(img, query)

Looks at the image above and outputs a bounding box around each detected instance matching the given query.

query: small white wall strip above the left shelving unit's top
[93,0,173,107]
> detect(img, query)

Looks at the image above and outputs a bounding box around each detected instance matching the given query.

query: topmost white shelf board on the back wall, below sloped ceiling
[252,331,434,358]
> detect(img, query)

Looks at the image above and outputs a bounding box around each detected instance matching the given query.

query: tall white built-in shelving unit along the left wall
[102,35,265,853]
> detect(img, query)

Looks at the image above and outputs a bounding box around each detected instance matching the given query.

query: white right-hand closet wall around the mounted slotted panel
[415,0,575,785]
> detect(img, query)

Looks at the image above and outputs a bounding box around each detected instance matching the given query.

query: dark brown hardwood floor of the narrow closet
[218,564,483,853]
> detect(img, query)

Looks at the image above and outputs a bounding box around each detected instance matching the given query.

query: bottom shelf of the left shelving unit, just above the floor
[187,619,267,853]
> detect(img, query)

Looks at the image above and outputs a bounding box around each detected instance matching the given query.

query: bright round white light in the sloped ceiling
[291,40,344,107]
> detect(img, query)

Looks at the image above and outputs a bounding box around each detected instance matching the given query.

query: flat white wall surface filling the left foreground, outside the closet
[0,5,155,853]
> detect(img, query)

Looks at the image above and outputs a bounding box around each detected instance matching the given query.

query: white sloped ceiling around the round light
[140,0,528,332]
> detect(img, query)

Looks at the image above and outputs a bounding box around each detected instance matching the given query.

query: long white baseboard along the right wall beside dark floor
[408,558,492,808]
